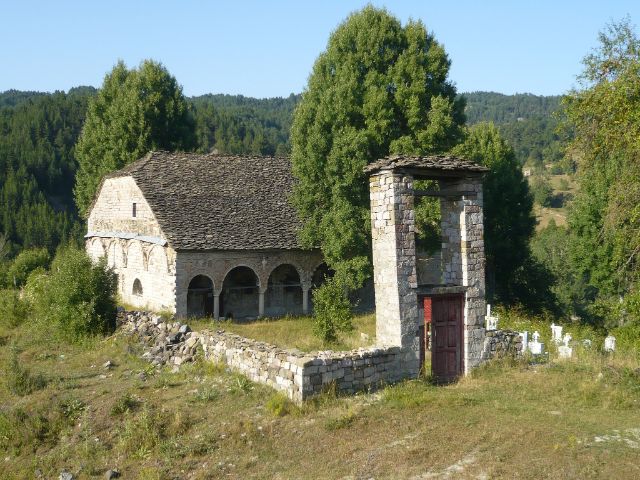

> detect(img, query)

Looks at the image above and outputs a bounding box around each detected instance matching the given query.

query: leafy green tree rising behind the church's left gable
[74,60,195,215]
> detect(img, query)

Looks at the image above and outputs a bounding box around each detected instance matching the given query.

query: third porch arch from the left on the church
[265,263,303,316]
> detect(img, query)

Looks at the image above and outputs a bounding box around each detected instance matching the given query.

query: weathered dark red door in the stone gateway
[424,295,464,382]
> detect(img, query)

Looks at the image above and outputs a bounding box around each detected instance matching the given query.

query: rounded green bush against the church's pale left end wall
[26,247,117,342]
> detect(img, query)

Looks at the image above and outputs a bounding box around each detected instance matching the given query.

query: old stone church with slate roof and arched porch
[85,152,329,318]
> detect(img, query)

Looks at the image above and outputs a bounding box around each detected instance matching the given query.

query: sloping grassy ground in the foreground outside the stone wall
[0,320,640,479]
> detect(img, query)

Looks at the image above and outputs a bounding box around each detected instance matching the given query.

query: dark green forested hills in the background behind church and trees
[0,87,562,256]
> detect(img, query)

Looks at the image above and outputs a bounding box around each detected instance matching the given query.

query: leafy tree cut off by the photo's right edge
[564,19,640,326]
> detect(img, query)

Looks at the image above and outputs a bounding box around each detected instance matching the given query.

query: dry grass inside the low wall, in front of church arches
[189,313,376,352]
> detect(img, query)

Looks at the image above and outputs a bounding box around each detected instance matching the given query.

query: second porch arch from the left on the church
[220,265,260,318]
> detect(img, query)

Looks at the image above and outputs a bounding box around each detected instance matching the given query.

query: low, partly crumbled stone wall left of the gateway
[119,312,418,402]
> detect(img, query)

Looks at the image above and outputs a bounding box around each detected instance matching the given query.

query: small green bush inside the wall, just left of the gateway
[313,275,353,342]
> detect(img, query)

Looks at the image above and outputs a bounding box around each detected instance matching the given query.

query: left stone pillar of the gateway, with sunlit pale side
[369,170,420,376]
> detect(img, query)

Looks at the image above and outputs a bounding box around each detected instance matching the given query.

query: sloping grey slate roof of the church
[106,152,301,250]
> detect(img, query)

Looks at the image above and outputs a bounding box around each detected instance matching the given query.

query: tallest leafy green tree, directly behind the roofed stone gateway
[291,6,464,283]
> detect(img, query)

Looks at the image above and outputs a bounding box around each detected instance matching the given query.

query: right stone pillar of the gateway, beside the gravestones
[440,178,486,373]
